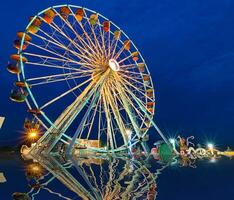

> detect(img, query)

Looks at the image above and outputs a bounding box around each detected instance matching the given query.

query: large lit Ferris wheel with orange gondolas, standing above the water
[8,5,169,151]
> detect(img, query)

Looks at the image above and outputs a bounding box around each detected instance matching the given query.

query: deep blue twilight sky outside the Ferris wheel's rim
[0,0,234,146]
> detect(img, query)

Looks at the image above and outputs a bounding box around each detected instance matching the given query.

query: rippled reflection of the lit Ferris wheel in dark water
[23,157,161,200]
